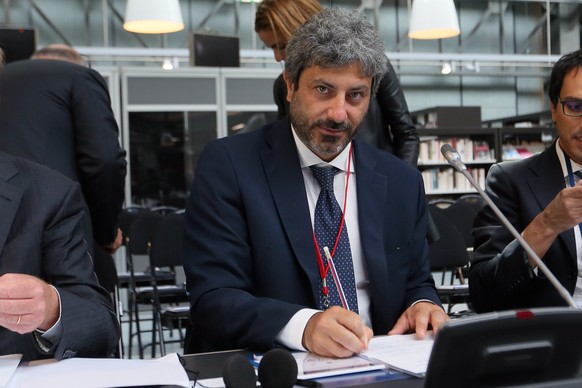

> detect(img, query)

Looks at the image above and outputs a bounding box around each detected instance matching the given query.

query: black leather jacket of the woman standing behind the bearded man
[273,62,419,166]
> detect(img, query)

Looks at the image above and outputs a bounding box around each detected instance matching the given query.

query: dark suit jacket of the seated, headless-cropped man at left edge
[0,153,119,360]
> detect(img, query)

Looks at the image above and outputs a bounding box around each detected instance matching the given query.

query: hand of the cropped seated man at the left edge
[0,273,60,334]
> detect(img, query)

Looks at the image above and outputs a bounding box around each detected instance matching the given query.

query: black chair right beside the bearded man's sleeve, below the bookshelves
[427,203,470,314]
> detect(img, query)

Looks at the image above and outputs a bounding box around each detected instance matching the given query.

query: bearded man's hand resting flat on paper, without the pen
[388,302,449,339]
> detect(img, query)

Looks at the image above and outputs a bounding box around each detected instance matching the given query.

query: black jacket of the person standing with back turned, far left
[0,59,126,249]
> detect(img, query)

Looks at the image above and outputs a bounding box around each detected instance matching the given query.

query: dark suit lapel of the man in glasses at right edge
[528,147,576,261]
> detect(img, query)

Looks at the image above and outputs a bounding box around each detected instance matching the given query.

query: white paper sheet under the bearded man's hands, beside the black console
[362,332,434,376]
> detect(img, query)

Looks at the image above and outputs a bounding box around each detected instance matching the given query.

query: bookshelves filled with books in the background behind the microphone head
[411,107,556,198]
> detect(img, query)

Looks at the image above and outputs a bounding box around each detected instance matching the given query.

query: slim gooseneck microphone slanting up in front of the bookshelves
[441,144,578,308]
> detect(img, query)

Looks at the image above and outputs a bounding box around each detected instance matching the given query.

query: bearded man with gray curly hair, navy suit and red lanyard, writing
[184,8,447,357]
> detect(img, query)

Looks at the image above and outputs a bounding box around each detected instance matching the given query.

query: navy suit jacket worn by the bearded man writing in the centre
[184,119,440,351]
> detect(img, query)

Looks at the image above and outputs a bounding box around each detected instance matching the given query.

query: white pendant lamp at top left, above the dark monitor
[123,0,184,34]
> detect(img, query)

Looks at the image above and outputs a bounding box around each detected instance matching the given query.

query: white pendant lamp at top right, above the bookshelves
[408,0,461,39]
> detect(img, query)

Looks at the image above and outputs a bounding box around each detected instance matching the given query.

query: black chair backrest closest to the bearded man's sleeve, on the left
[149,213,184,268]
